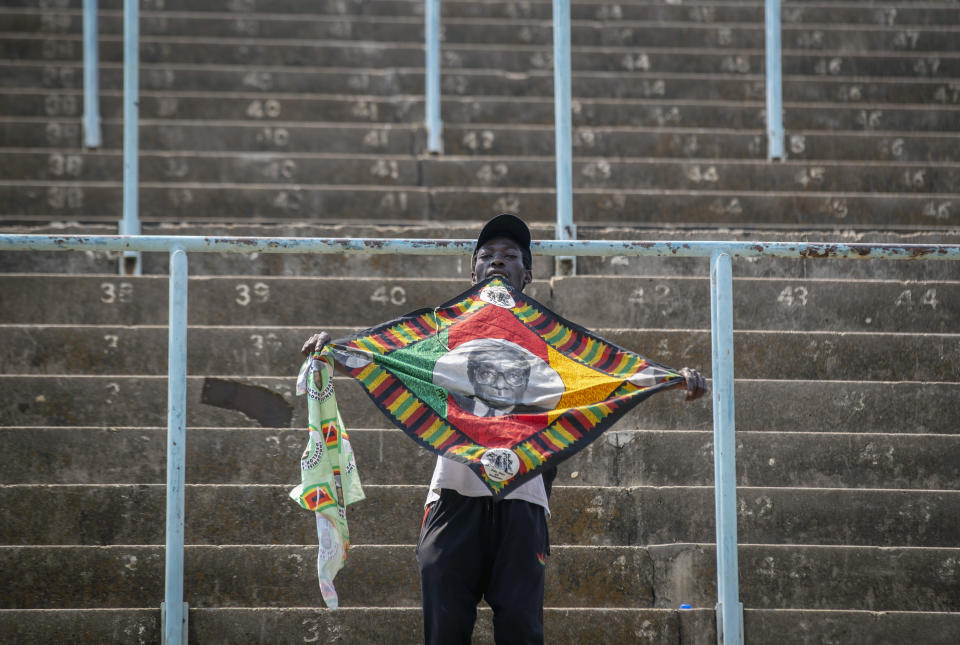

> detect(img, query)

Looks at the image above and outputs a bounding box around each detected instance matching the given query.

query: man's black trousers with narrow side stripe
[417,490,549,645]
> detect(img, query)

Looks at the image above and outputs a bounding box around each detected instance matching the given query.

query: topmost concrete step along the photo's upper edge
[6,0,960,26]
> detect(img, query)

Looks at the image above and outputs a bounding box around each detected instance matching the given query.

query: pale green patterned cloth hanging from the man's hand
[290,352,366,609]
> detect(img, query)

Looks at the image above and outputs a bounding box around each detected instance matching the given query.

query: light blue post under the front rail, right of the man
[710,252,743,645]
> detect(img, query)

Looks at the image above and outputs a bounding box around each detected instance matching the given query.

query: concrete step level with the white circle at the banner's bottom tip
[7,420,960,490]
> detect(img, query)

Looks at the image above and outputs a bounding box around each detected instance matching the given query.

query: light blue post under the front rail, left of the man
[161,248,187,645]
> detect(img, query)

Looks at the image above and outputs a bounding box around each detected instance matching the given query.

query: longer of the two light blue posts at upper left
[120,0,141,275]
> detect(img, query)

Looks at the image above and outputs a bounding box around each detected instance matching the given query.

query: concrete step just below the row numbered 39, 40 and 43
[7,324,960,381]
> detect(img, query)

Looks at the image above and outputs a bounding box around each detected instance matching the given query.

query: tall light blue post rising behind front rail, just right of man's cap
[553,0,577,275]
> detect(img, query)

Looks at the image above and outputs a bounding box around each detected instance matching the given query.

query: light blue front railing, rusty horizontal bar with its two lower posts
[0,235,960,645]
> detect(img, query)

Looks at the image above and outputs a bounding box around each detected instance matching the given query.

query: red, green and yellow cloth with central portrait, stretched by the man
[327,277,684,498]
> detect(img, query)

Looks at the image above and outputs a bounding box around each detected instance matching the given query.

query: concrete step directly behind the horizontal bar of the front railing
[0,223,960,280]
